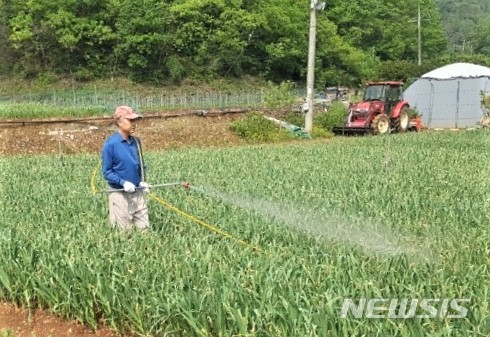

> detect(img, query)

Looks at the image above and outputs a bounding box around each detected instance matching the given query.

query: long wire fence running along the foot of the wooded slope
[0,90,265,110]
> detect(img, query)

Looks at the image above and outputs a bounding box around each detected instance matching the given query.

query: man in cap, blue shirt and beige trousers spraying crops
[102,106,150,230]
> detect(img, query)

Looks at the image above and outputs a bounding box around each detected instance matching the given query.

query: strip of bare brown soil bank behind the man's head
[0,114,243,155]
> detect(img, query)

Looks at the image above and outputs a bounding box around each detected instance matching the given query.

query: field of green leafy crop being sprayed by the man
[0,130,490,337]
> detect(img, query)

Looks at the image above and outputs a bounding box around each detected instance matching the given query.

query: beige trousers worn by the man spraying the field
[109,190,150,230]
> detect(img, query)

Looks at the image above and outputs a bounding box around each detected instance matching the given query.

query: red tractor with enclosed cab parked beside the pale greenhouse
[333,81,420,135]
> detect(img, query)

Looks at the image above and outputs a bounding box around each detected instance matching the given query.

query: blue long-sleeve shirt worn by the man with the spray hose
[102,132,144,189]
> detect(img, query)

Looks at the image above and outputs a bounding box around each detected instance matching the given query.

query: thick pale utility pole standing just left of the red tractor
[305,0,325,132]
